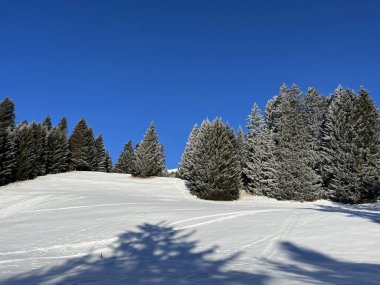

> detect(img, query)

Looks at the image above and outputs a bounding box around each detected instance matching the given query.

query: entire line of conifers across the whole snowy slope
[0,85,380,203]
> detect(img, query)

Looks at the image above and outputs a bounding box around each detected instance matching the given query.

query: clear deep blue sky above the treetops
[0,0,380,168]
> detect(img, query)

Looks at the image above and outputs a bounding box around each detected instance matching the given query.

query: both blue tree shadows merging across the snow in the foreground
[1,223,380,285]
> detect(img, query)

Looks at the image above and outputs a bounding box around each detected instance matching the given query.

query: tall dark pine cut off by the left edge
[0,98,16,186]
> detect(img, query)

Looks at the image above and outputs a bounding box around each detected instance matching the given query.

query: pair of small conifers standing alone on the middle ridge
[113,122,165,177]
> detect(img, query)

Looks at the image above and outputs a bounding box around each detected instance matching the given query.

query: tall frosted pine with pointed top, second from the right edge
[321,86,360,203]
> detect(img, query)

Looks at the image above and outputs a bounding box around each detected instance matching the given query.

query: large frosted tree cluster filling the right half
[178,85,380,203]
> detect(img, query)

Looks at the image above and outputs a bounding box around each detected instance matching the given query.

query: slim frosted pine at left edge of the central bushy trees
[178,124,199,180]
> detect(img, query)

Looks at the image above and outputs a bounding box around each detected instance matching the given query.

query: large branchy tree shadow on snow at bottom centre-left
[1,223,267,285]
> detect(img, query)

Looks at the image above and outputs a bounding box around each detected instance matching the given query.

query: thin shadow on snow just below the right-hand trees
[317,204,380,224]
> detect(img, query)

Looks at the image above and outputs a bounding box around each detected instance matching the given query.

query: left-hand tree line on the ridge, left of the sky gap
[0,98,165,186]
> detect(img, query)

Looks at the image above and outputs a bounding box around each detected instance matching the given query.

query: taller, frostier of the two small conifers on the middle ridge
[132,122,165,177]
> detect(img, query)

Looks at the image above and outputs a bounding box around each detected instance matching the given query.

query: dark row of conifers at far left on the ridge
[0,98,112,185]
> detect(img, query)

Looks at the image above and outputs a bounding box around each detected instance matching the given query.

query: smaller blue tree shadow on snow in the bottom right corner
[267,242,380,285]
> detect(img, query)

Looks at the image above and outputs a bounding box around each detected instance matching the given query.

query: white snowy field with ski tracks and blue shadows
[0,172,380,285]
